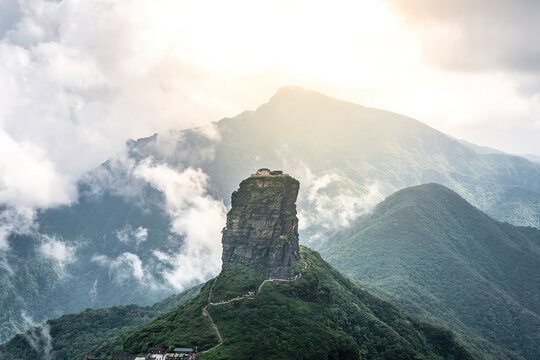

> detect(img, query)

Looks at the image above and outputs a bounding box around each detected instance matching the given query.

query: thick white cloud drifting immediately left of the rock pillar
[134,160,225,290]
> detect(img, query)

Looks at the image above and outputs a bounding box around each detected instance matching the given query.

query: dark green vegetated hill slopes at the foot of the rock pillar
[120,247,471,360]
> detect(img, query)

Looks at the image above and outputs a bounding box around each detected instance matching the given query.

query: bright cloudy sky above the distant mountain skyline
[0,0,540,211]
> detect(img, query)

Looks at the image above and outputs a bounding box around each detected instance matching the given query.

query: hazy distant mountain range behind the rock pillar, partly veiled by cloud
[0,87,540,341]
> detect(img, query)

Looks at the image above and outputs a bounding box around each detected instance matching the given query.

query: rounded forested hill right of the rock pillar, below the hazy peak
[323,184,540,360]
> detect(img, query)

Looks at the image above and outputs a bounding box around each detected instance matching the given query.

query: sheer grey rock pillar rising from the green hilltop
[222,175,300,276]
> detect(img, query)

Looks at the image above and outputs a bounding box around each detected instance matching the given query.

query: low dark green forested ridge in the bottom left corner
[0,285,201,360]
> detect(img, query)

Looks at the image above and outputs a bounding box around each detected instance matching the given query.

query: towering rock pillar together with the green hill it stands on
[116,173,471,359]
